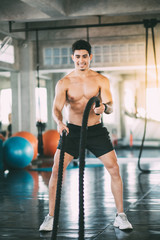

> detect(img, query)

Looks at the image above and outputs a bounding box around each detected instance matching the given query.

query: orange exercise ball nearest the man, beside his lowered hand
[43,130,60,157]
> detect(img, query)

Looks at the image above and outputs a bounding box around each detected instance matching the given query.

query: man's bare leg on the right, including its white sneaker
[99,150,132,230]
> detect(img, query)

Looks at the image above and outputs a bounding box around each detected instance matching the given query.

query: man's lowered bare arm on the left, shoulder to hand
[53,79,68,134]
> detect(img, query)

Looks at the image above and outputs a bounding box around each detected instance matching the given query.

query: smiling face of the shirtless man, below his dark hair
[72,50,92,71]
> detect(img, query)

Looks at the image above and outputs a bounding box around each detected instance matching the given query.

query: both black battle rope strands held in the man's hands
[51,97,100,240]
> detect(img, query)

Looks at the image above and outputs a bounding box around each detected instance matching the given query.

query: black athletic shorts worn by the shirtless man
[57,123,113,158]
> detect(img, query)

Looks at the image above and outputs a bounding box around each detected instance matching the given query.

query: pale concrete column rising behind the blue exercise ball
[19,42,37,135]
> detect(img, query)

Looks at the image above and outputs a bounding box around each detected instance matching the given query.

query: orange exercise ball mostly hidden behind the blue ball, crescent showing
[12,131,38,160]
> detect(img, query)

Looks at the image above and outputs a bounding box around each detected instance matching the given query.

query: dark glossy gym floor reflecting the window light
[0,149,160,240]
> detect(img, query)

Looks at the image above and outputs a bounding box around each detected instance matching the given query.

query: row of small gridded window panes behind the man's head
[44,43,145,66]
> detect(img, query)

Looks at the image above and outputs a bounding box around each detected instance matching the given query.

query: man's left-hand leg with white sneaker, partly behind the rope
[39,149,73,231]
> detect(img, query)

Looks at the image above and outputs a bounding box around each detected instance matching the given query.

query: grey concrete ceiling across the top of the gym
[0,0,160,22]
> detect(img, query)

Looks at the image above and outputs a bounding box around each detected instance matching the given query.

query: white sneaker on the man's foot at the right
[113,213,133,230]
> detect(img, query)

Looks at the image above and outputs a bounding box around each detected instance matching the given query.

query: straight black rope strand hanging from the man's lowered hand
[51,130,66,240]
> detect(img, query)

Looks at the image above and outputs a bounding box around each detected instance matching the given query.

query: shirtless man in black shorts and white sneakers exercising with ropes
[39,40,132,231]
